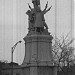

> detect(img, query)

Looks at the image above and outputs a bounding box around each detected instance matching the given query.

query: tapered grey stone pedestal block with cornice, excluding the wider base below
[22,35,53,66]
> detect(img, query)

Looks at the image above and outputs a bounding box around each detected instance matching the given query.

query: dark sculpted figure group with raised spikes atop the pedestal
[26,0,52,32]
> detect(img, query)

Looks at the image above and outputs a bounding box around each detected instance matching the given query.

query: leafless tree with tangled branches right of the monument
[52,34,75,71]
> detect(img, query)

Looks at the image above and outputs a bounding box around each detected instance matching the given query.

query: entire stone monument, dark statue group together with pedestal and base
[21,0,57,75]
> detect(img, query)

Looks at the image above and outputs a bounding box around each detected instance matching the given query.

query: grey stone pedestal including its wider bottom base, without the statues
[21,31,57,75]
